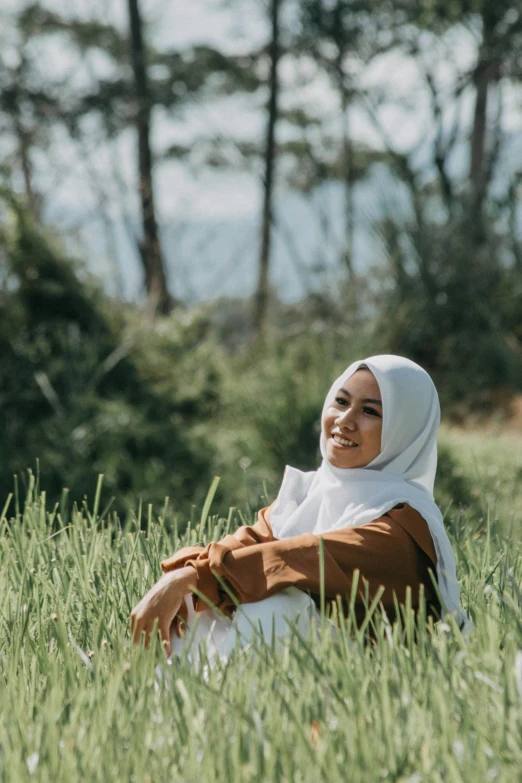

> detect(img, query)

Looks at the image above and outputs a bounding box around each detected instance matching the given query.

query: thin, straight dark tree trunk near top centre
[254,0,280,340]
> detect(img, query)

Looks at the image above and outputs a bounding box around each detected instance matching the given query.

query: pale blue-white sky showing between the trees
[0,0,522,301]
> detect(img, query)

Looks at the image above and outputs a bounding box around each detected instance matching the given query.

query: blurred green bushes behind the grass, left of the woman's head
[0,210,484,513]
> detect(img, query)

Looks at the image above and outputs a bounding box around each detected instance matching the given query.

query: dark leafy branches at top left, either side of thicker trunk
[0,3,260,152]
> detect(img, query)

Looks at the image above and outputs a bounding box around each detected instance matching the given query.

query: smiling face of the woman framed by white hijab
[321,370,382,468]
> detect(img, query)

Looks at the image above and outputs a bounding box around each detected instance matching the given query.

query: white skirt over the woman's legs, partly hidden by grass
[169,587,321,665]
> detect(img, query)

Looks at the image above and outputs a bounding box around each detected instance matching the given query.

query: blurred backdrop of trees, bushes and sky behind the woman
[0,0,522,516]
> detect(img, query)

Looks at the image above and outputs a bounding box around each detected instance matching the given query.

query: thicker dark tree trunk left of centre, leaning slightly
[128,0,173,314]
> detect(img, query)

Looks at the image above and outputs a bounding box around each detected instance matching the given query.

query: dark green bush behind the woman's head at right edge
[372,208,522,419]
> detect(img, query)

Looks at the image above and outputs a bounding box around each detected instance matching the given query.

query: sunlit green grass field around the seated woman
[0,430,522,783]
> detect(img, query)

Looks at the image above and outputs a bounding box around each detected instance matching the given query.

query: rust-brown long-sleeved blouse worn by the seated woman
[161,504,439,619]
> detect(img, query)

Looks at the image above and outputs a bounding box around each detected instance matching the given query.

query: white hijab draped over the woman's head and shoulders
[270,355,469,630]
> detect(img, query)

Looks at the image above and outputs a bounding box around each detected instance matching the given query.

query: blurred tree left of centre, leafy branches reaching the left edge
[0,0,253,312]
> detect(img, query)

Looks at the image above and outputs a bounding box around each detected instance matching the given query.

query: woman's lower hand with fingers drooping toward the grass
[131,566,197,655]
